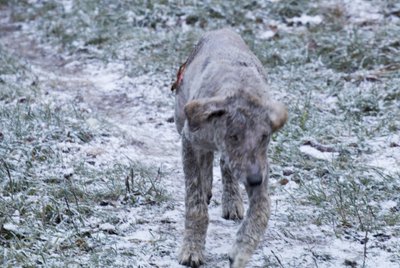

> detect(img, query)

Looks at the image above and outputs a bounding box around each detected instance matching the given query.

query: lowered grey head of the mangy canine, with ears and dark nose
[185,92,288,186]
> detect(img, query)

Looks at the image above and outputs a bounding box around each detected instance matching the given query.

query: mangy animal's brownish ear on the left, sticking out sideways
[184,98,226,131]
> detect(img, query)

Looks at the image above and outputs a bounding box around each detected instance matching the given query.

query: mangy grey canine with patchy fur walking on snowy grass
[172,29,288,268]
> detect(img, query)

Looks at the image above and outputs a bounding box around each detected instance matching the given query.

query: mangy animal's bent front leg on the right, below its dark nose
[229,182,271,268]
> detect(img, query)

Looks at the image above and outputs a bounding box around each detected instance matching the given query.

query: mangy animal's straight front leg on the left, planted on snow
[179,137,213,267]
